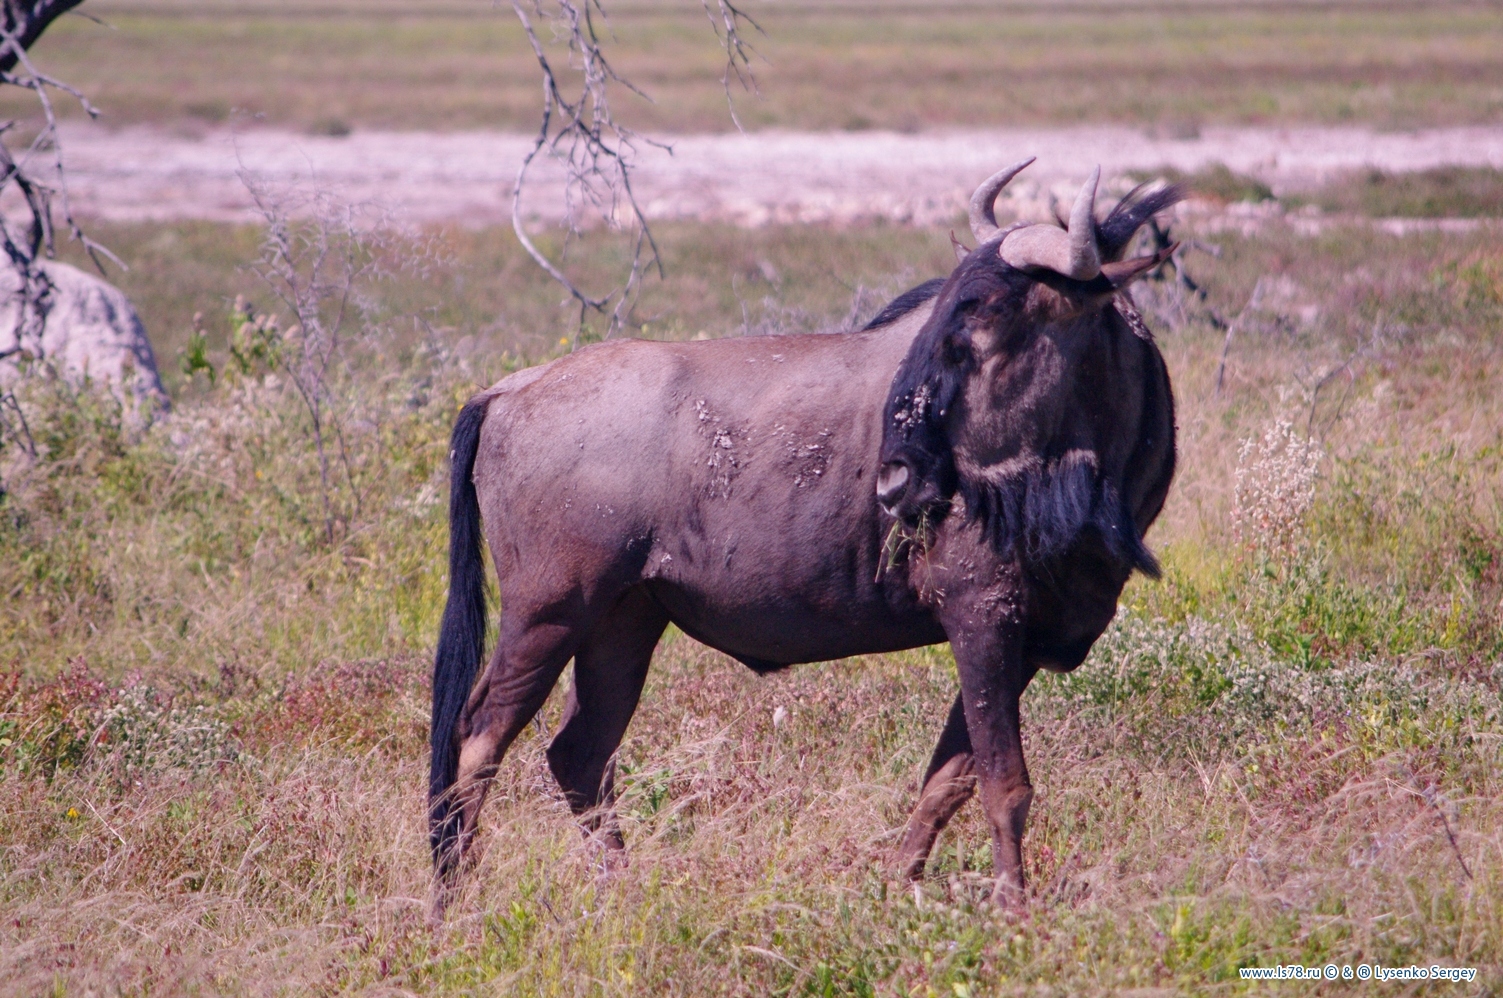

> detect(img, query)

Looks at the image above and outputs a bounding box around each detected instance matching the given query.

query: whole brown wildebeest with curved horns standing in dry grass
[428,161,1180,912]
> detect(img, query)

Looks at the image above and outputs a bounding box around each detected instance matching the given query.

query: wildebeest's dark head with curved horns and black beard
[876,159,1183,573]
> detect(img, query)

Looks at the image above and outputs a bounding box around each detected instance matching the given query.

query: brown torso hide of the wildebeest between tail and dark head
[473,307,944,669]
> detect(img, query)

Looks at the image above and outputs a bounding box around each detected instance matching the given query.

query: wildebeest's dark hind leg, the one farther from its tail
[549,589,667,851]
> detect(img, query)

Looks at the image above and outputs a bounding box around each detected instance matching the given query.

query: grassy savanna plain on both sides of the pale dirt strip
[0,3,1503,998]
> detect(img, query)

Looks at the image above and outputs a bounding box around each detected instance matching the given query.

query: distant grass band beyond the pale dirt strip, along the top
[11,0,1503,135]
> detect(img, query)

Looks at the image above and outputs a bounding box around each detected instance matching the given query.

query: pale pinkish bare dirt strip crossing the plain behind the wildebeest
[38,125,1503,225]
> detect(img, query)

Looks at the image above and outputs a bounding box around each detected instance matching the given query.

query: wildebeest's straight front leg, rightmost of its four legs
[941,565,1036,908]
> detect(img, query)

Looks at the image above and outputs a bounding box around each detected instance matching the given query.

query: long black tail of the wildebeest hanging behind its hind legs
[428,395,491,866]
